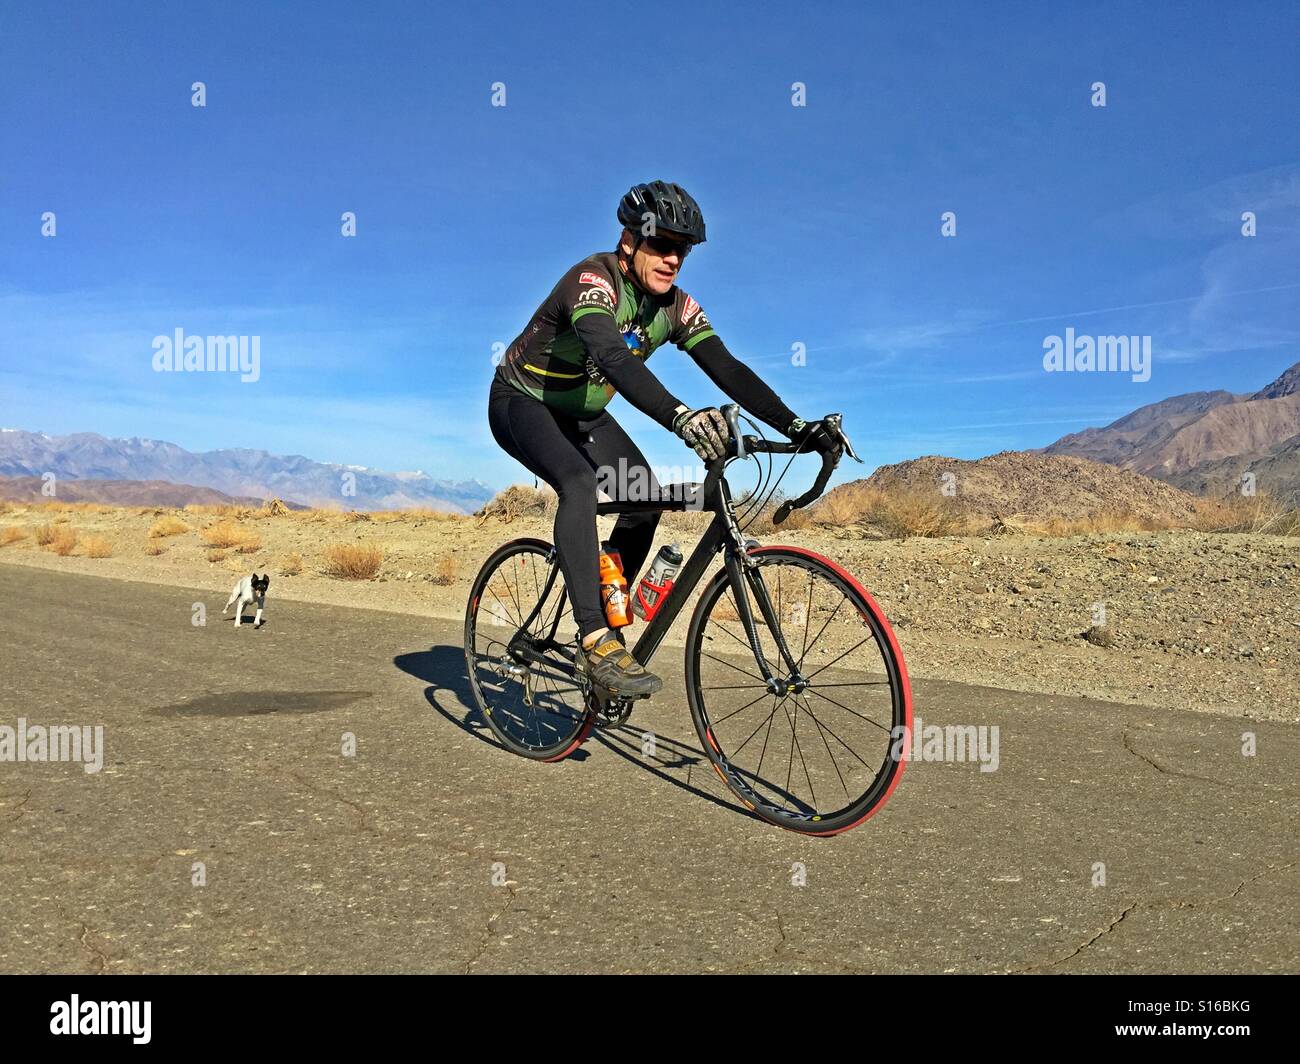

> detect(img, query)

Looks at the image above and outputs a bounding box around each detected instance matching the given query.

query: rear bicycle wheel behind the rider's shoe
[465,539,594,761]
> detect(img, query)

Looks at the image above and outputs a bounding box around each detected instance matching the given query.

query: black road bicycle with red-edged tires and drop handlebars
[465,405,911,835]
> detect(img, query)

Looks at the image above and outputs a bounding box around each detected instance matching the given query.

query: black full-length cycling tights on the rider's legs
[488,377,659,636]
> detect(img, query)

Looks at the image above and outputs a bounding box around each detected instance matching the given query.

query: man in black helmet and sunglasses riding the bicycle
[488,181,837,697]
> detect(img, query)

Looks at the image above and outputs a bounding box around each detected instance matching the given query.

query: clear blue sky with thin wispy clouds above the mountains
[0,1,1300,489]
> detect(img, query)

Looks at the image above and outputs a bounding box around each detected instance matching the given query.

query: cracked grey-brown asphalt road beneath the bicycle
[0,566,1300,973]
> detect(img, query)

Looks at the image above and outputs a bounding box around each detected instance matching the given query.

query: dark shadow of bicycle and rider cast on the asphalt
[393,645,764,823]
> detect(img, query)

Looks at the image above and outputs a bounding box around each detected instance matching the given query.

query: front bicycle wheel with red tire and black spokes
[686,546,911,835]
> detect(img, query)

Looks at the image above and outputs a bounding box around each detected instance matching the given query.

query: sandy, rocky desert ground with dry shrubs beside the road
[0,506,1300,721]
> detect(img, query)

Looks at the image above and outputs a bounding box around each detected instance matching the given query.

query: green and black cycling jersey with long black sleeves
[497,251,794,432]
